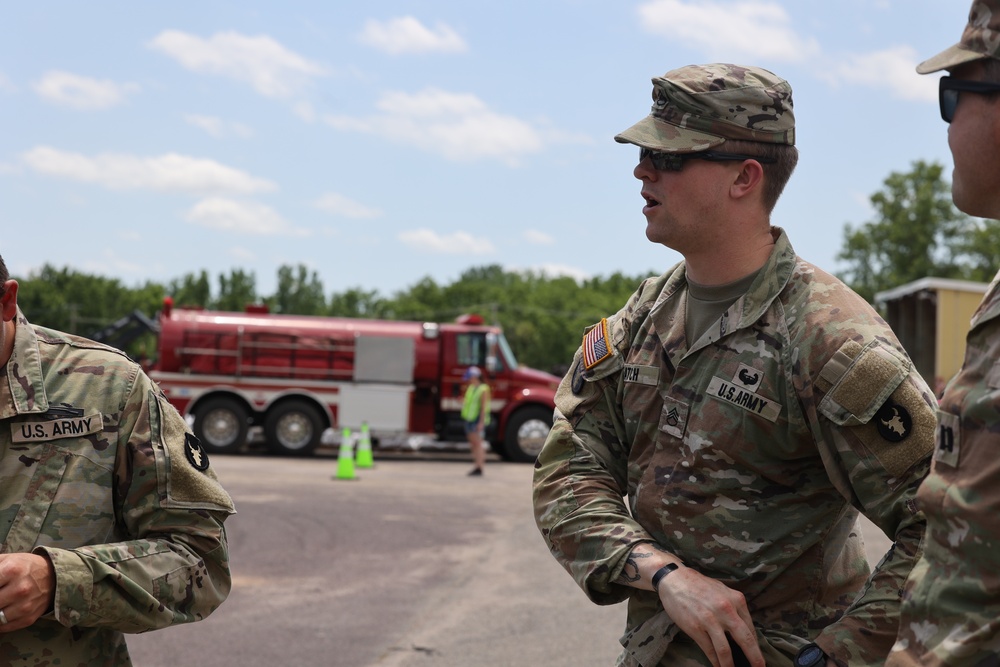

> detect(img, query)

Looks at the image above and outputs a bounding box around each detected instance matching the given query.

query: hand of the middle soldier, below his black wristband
[657,567,765,667]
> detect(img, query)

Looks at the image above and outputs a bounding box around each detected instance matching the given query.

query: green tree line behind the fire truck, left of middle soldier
[14,264,653,373]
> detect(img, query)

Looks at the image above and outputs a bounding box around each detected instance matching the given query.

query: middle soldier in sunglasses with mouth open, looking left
[534,64,935,667]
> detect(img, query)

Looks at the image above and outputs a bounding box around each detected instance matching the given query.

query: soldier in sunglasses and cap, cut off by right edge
[887,0,1000,667]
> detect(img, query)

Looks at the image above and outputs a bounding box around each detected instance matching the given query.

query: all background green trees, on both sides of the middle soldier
[18,161,1000,373]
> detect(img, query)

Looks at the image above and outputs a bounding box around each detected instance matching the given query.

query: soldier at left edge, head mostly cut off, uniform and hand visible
[0,253,234,667]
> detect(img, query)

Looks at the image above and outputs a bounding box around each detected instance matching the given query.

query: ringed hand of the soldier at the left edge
[0,553,56,632]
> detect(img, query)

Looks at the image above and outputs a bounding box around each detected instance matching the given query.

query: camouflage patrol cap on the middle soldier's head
[615,63,795,153]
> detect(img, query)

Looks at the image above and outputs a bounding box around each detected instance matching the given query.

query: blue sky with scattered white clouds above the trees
[0,0,968,296]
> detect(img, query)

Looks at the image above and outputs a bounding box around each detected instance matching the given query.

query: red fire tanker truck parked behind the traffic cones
[150,300,559,461]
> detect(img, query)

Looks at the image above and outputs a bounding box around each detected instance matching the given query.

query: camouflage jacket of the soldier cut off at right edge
[887,274,1000,666]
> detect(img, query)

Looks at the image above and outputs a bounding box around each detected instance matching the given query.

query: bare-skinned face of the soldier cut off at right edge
[948,61,1000,218]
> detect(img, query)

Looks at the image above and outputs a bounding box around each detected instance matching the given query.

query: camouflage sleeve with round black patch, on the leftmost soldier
[36,373,234,632]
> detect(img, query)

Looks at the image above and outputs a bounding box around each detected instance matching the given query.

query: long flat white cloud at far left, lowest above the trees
[21,146,277,194]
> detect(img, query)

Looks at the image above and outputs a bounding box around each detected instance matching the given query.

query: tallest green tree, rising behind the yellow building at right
[837,160,979,301]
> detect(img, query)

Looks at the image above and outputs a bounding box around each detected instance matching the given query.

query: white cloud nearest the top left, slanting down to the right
[149,30,325,98]
